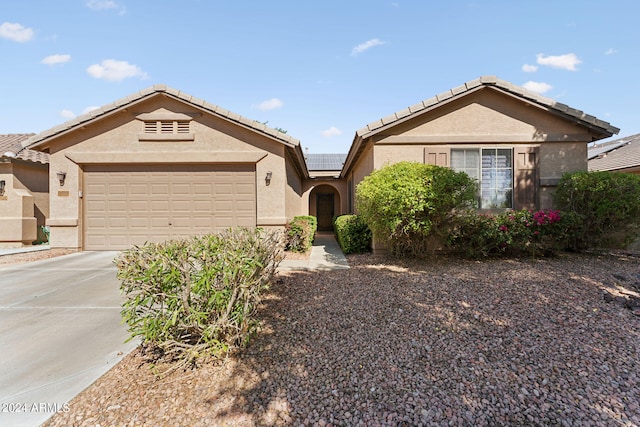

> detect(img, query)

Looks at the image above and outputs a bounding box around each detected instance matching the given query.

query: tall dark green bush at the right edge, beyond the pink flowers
[554,172,640,250]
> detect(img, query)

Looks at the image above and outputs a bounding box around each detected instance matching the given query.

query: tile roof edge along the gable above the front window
[356,76,620,138]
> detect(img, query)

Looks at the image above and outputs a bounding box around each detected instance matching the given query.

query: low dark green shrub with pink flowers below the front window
[447,210,575,258]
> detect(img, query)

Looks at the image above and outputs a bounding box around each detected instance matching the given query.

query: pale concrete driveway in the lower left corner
[0,252,137,426]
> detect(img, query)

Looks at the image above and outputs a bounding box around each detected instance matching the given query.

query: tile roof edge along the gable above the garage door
[22,85,300,147]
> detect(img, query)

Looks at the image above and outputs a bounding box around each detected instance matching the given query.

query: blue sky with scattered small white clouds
[0,0,640,153]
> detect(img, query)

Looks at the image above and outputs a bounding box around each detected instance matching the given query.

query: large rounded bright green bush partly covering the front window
[356,162,476,256]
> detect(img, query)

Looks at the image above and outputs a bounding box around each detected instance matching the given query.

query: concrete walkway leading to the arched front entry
[278,232,349,271]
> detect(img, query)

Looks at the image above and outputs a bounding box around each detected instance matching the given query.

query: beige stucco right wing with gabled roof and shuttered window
[341,77,619,217]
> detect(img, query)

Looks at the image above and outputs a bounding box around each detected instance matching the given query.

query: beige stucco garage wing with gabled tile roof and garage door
[23,85,309,250]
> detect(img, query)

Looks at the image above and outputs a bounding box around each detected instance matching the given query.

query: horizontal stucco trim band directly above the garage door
[65,151,267,165]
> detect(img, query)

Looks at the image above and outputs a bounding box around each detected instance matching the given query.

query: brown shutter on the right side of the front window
[513,147,540,210]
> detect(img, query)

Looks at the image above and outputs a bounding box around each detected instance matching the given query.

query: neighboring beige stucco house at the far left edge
[0,134,49,247]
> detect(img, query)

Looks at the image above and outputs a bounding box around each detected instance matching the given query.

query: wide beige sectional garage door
[83,165,256,250]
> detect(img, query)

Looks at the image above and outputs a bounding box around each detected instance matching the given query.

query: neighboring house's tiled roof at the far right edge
[589,134,640,175]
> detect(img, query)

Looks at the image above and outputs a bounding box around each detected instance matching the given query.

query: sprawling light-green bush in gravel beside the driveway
[115,228,282,362]
